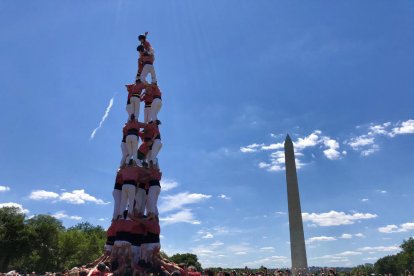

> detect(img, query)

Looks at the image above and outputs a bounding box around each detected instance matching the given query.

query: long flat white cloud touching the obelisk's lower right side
[302,210,377,226]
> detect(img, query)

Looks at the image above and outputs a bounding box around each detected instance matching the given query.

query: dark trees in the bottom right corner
[352,237,414,275]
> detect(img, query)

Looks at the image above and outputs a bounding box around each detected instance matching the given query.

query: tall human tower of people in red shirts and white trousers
[105,33,162,266]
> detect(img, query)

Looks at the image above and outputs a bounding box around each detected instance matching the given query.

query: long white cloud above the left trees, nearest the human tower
[29,189,109,204]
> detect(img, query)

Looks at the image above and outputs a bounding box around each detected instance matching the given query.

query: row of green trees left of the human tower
[0,207,106,273]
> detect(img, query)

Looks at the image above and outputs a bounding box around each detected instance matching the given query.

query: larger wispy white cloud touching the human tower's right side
[159,192,211,212]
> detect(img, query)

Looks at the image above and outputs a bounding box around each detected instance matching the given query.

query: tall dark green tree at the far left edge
[0,207,29,272]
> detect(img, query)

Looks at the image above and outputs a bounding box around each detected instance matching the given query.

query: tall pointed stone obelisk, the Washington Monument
[285,135,308,275]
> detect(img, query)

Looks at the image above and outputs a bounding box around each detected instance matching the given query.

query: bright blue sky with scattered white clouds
[0,1,414,267]
